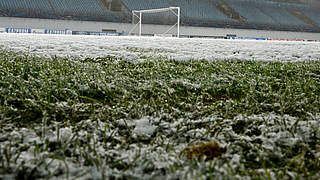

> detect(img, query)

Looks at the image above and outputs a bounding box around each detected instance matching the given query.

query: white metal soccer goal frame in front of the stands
[129,7,180,37]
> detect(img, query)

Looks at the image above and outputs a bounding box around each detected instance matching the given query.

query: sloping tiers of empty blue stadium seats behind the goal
[0,0,320,32]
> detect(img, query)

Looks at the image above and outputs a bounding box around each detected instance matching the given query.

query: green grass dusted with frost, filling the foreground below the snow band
[0,50,320,179]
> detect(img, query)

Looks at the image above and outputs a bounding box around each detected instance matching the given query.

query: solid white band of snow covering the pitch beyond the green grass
[0,33,320,62]
